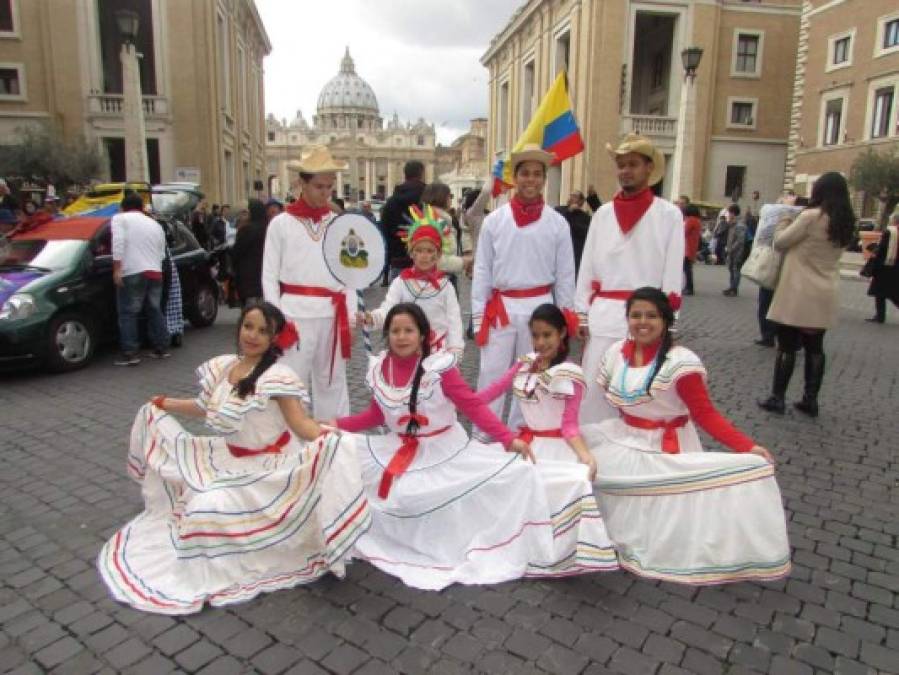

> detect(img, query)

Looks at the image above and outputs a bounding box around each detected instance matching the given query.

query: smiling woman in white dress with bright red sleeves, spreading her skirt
[582,287,790,584]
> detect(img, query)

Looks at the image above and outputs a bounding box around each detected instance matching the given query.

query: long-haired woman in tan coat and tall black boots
[758,172,855,417]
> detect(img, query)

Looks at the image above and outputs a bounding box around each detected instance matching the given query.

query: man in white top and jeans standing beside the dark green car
[111,192,171,366]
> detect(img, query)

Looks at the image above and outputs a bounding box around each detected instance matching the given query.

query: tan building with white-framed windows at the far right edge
[784,0,899,215]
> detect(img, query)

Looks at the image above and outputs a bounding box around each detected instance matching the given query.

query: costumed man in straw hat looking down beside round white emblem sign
[262,146,356,420]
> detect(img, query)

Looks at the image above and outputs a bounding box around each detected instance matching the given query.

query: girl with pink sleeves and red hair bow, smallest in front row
[478,304,618,576]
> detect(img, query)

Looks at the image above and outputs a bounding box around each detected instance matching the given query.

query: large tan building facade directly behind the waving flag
[481,0,801,203]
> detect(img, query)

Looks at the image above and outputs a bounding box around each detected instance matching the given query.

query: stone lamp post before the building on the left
[115,9,150,183]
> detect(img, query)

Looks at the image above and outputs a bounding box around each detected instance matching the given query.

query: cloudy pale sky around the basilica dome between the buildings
[256,0,523,144]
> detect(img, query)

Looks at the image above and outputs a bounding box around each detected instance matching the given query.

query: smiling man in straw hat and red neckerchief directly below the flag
[471,144,575,429]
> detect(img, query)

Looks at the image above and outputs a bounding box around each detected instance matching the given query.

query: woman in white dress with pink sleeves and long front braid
[335,303,580,590]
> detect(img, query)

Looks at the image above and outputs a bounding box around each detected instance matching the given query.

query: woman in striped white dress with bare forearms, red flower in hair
[97,303,371,614]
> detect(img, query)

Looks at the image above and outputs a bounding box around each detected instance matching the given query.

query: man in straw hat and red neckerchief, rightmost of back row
[575,134,684,423]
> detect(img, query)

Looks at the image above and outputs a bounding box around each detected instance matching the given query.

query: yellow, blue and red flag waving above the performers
[493,71,584,197]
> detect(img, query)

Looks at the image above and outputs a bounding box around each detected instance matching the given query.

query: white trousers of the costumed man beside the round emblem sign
[281,318,350,420]
